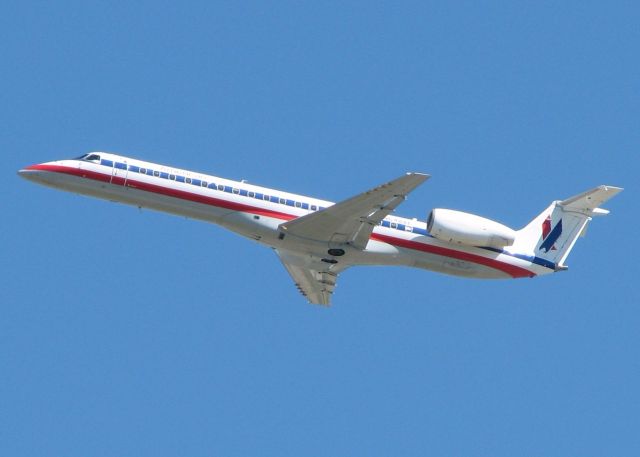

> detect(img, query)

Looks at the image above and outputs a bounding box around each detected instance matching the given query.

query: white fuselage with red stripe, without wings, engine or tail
[20,153,554,278]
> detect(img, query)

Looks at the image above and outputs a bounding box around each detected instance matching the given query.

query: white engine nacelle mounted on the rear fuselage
[427,208,516,249]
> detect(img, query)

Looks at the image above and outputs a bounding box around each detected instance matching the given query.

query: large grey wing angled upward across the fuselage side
[280,173,429,249]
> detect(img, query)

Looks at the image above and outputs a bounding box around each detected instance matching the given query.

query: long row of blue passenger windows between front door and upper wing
[100,159,325,211]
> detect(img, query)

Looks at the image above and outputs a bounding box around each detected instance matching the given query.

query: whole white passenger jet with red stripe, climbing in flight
[18,152,623,306]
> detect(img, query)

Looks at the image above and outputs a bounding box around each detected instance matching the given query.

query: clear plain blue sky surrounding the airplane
[0,1,640,456]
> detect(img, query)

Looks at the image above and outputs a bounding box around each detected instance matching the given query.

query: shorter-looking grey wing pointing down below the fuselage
[276,249,344,306]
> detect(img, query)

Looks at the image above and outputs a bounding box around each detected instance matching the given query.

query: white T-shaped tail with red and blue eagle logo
[513,186,622,271]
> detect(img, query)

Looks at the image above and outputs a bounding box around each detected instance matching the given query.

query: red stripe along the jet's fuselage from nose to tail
[31,164,535,278]
